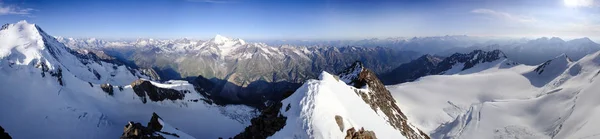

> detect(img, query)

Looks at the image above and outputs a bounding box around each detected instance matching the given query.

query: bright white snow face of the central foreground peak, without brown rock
[269,72,404,139]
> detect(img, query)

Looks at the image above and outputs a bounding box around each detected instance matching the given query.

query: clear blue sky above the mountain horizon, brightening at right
[0,0,600,40]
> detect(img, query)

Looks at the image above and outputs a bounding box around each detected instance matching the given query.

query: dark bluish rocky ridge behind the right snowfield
[380,50,510,85]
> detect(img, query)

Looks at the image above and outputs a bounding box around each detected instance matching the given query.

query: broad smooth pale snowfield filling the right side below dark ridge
[387,49,600,138]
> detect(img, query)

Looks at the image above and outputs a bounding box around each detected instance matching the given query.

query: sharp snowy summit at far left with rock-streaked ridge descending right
[0,21,155,85]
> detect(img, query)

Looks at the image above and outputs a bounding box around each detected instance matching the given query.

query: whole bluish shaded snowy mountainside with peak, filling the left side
[0,21,257,138]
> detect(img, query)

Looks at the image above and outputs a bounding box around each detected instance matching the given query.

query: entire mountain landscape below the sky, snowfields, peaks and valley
[0,21,600,139]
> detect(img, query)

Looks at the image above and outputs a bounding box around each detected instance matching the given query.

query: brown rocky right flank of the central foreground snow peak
[339,62,429,139]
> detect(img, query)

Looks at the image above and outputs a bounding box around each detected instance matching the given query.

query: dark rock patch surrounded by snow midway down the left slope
[131,79,189,103]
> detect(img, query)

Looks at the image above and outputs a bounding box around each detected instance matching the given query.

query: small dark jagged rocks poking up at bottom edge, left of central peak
[121,113,179,139]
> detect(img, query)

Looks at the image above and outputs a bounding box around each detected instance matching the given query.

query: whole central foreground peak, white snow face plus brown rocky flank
[270,62,429,139]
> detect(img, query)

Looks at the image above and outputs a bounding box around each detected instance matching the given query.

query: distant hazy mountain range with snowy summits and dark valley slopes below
[58,35,419,104]
